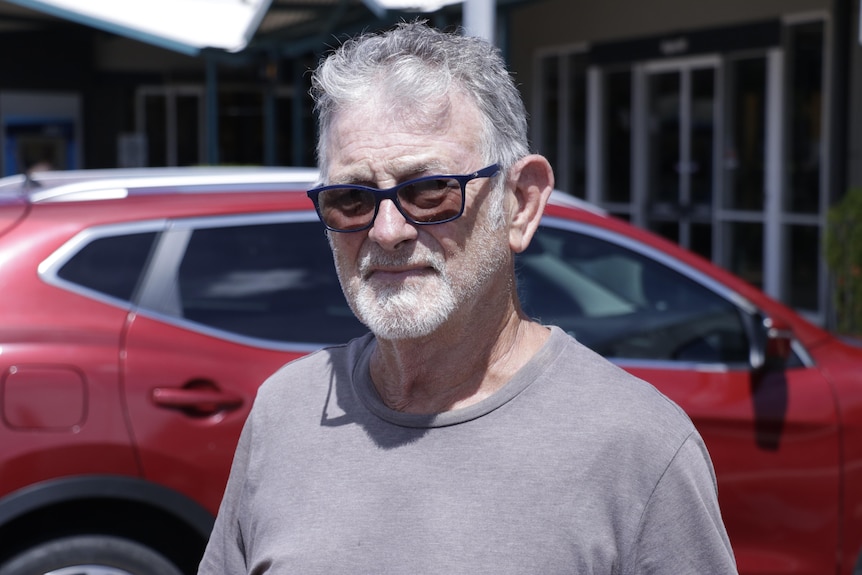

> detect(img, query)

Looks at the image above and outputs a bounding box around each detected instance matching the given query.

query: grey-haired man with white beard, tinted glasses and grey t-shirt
[200,23,735,575]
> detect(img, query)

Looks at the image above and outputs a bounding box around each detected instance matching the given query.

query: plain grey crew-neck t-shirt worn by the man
[199,328,736,575]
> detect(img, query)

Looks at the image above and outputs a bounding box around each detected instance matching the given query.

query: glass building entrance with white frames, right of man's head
[533,16,828,323]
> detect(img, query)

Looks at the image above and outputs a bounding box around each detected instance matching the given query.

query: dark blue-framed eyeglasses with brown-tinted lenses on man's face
[308,164,500,232]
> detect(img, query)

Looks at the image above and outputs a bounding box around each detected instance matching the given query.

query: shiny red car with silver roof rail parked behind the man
[0,168,862,575]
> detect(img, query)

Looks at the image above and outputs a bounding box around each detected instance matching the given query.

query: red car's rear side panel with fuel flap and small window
[0,225,155,494]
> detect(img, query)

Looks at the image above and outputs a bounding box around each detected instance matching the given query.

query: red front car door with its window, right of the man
[518,218,839,575]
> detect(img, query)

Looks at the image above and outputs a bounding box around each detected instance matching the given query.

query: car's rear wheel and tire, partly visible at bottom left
[0,535,183,575]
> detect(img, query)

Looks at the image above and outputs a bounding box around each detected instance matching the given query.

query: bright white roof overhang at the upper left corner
[2,0,274,55]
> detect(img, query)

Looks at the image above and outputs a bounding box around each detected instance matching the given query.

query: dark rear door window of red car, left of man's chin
[178,222,367,343]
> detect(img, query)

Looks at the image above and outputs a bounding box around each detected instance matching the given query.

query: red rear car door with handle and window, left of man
[123,213,364,513]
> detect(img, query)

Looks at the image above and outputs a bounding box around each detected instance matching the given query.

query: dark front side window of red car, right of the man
[517,227,749,363]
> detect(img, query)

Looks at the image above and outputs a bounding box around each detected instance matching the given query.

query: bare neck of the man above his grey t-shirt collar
[371,310,550,413]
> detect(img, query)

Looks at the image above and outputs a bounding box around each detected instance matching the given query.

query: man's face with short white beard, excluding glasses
[326,95,511,339]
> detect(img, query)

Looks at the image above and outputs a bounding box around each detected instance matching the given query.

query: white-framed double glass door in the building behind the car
[644,60,718,259]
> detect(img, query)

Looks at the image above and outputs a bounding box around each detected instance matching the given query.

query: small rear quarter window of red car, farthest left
[57,232,156,301]
